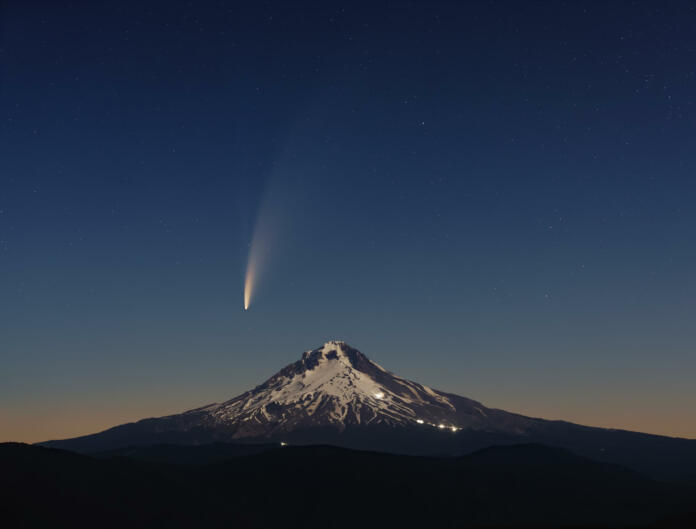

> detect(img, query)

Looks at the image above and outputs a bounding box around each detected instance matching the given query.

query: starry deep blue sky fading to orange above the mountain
[0,1,696,441]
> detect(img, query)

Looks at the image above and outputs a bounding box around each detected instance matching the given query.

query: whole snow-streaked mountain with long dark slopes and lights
[41,341,696,478]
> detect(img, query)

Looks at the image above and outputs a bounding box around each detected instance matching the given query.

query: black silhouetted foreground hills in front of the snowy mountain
[0,444,692,529]
